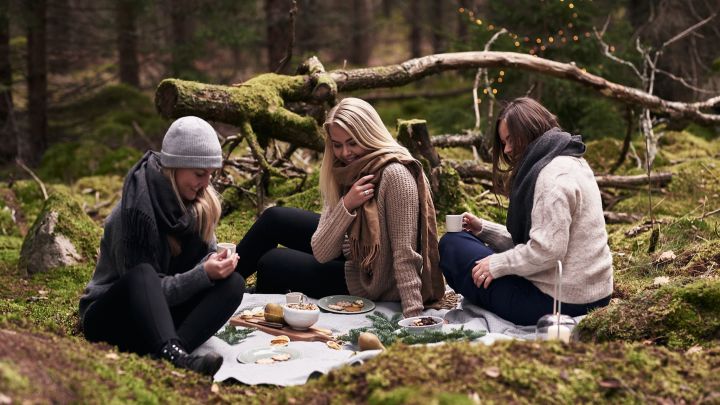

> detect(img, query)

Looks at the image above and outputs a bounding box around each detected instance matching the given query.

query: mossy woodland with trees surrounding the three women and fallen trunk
[0,0,720,403]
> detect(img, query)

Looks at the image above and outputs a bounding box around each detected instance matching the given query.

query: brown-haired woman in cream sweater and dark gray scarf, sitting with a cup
[440,97,613,325]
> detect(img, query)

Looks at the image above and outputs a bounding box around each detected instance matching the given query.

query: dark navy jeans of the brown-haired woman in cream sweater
[440,232,610,325]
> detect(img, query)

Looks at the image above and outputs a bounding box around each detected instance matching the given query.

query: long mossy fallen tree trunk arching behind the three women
[155,51,720,144]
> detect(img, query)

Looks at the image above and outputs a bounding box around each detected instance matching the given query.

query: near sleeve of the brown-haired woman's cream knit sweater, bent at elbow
[490,163,580,278]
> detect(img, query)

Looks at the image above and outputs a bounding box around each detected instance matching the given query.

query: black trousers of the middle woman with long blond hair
[236,207,348,298]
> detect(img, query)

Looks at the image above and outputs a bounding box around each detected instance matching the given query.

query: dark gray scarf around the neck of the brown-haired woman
[506,128,585,245]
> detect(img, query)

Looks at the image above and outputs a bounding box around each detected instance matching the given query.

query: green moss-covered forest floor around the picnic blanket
[0,88,720,404]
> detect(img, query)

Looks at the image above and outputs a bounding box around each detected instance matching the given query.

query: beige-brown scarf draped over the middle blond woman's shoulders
[333,150,445,302]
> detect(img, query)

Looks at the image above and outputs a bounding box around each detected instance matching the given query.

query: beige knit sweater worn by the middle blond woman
[311,163,423,317]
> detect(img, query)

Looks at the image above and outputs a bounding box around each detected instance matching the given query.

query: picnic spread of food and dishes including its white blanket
[194,294,581,386]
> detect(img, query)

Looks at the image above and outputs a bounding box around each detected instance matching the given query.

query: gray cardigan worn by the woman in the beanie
[80,204,217,320]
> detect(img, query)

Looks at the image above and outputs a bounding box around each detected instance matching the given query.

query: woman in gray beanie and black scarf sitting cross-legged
[80,117,245,375]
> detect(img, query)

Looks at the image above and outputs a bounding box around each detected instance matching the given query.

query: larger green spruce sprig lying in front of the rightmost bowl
[339,311,485,346]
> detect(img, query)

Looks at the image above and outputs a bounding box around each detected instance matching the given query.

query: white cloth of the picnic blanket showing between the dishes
[193,294,580,386]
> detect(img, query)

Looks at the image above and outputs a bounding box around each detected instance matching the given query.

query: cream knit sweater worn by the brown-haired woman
[476,156,613,304]
